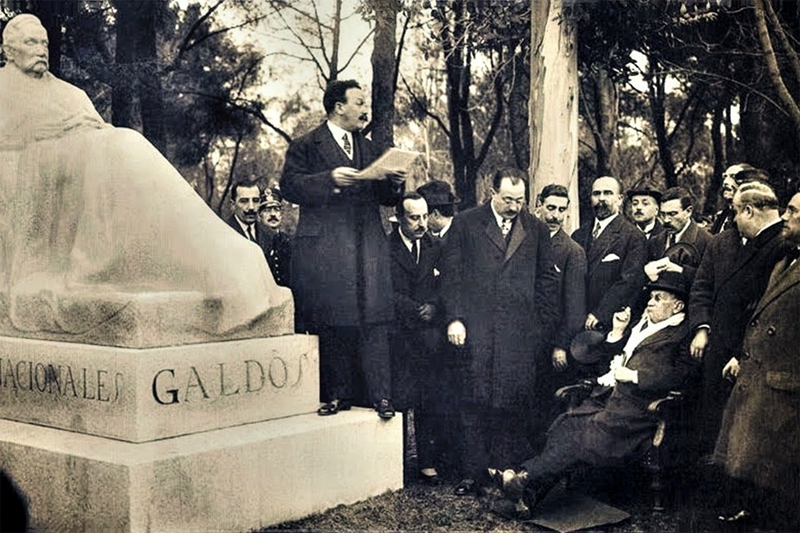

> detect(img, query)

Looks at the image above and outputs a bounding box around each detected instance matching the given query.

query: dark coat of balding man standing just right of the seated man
[689,224,787,366]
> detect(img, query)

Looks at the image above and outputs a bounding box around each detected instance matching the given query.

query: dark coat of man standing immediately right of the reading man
[389,229,444,409]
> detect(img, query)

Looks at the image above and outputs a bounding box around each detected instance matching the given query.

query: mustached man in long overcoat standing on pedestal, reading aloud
[280,80,405,419]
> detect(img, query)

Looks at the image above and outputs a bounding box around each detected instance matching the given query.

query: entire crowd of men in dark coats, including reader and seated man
[222,81,800,526]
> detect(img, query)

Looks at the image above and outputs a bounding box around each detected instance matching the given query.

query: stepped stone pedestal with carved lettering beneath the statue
[0,335,403,532]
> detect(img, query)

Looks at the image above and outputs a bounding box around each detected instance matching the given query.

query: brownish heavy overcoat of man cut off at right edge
[715,255,800,490]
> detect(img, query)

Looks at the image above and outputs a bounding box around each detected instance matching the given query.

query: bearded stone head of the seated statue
[3,14,49,78]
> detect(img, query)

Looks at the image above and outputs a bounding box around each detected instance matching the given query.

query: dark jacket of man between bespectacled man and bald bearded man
[550,229,586,350]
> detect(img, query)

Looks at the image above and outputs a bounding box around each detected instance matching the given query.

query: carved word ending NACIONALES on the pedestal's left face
[0,357,124,402]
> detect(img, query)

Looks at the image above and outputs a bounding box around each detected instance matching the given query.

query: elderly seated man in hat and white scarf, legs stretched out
[489,272,694,518]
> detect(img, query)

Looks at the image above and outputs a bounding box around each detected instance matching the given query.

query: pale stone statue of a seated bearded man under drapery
[0,14,293,347]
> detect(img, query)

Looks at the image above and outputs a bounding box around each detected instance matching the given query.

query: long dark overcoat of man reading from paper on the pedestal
[280,124,402,333]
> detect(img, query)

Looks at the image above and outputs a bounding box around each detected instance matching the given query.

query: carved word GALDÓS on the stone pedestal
[152,350,308,405]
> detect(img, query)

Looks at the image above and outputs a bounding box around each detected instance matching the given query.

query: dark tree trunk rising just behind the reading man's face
[370,2,397,151]
